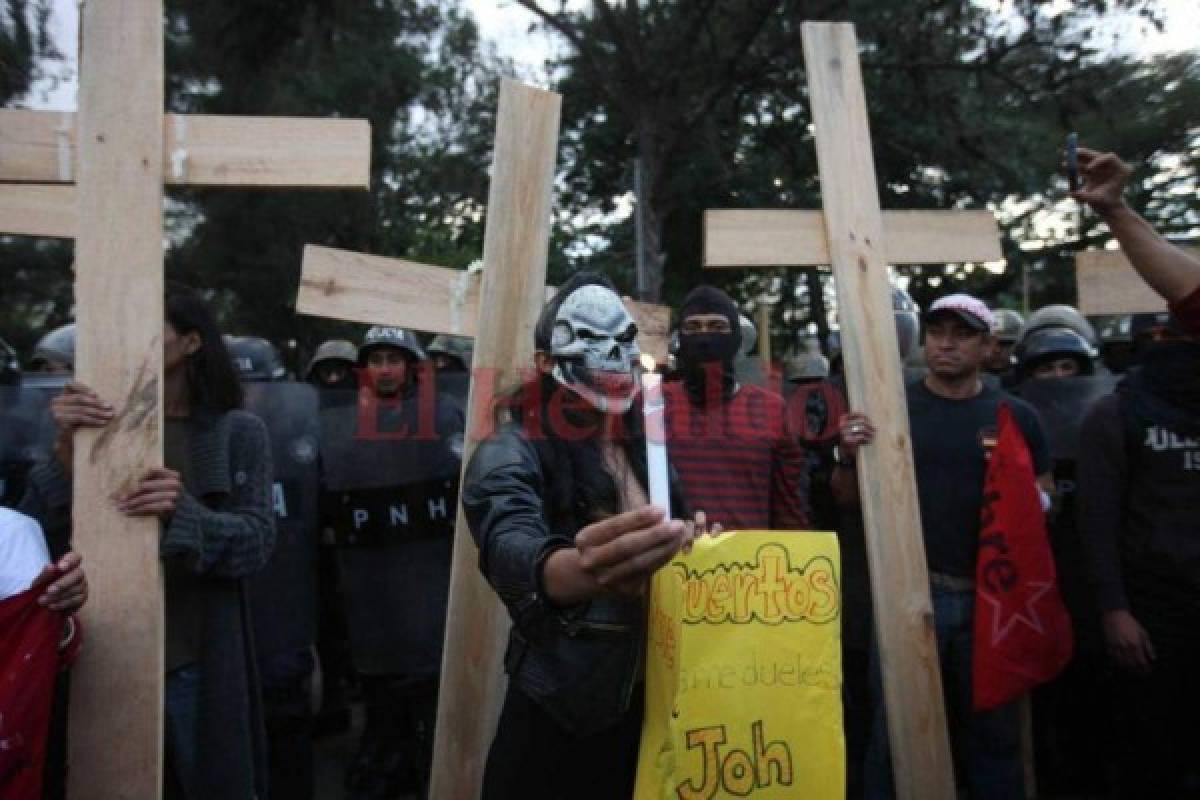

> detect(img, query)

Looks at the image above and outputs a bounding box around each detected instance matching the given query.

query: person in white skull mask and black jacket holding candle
[462,273,703,800]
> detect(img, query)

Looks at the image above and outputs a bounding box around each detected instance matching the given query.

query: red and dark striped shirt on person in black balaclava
[664,383,809,530]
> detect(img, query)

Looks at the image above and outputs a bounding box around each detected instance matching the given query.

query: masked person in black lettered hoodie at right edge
[1076,318,1200,798]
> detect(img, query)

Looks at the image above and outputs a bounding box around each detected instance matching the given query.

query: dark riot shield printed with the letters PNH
[320,369,467,679]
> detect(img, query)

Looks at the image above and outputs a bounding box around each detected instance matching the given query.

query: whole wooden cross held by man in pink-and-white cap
[704,23,1002,800]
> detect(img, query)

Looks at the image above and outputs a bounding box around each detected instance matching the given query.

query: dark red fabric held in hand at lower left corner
[0,582,79,800]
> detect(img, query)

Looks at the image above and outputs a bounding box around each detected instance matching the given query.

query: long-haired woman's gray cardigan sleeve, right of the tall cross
[160,414,275,578]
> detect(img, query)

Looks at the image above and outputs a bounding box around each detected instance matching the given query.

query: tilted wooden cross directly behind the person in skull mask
[296,80,561,799]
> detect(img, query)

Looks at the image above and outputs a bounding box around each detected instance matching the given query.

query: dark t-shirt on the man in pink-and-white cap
[907,380,1051,578]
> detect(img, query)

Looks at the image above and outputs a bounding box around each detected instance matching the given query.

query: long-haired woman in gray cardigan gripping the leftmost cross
[22,285,275,800]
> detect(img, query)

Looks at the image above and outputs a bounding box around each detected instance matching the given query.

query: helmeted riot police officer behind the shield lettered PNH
[322,326,464,799]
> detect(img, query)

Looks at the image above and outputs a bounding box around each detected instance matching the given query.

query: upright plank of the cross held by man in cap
[803,23,955,800]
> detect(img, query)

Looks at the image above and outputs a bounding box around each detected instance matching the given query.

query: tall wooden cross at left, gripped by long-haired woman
[0,0,371,800]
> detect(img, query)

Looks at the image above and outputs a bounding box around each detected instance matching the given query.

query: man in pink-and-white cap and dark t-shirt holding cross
[833,295,1051,799]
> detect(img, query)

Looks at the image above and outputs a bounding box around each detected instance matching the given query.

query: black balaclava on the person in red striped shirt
[676,285,742,405]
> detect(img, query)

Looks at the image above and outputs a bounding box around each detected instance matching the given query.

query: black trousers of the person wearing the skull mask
[482,684,642,800]
